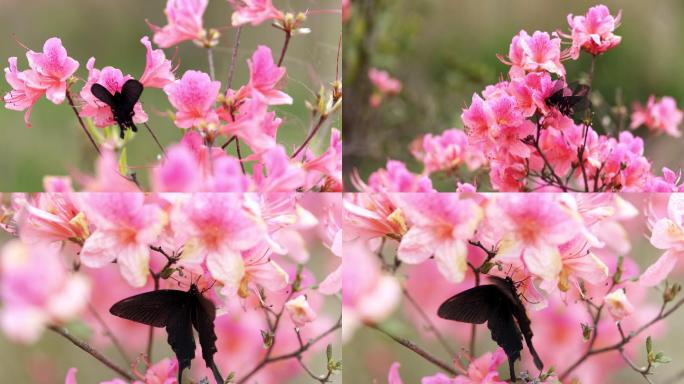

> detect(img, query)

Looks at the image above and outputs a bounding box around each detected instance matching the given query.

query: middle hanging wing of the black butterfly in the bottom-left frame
[166,304,195,383]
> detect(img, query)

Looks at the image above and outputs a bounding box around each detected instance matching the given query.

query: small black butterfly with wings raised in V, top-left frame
[90,79,143,139]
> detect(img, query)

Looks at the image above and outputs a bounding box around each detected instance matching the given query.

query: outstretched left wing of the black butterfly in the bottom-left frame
[109,289,189,327]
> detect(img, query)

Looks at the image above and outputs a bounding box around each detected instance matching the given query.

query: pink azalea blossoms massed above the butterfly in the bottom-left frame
[0,193,342,366]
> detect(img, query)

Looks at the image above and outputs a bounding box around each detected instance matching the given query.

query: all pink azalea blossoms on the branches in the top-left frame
[4,0,342,192]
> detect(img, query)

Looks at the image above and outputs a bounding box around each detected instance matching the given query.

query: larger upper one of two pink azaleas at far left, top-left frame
[25,37,79,104]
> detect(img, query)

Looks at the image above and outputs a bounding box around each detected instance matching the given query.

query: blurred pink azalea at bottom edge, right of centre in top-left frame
[253,145,306,193]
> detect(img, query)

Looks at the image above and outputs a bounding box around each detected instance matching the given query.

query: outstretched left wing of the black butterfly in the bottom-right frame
[437,285,501,324]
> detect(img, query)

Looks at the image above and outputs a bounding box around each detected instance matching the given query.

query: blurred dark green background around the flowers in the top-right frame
[343,0,684,190]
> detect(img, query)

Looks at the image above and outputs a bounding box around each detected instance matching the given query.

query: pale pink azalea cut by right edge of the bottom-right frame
[639,193,684,287]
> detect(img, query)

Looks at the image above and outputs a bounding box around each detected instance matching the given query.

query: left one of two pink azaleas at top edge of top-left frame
[147,0,209,48]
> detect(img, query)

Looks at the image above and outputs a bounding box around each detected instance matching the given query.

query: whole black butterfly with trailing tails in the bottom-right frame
[437,276,544,381]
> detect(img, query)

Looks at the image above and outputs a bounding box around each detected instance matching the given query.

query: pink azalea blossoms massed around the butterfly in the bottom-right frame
[343,193,672,384]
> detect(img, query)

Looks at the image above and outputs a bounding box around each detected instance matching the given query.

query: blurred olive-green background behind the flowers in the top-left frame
[0,0,341,191]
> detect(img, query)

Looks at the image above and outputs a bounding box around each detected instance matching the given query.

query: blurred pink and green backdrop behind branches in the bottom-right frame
[342,194,684,384]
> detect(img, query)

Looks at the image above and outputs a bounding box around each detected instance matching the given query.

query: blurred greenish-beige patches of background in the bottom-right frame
[342,193,684,384]
